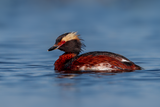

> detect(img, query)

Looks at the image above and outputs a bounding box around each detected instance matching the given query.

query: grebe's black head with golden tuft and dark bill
[48,32,85,54]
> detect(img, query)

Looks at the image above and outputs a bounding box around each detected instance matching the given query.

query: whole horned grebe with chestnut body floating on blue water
[48,32,142,72]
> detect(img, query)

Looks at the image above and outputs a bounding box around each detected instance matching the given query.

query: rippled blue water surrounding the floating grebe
[0,0,160,107]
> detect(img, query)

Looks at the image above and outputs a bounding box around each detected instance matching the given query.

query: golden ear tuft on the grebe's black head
[62,32,80,42]
